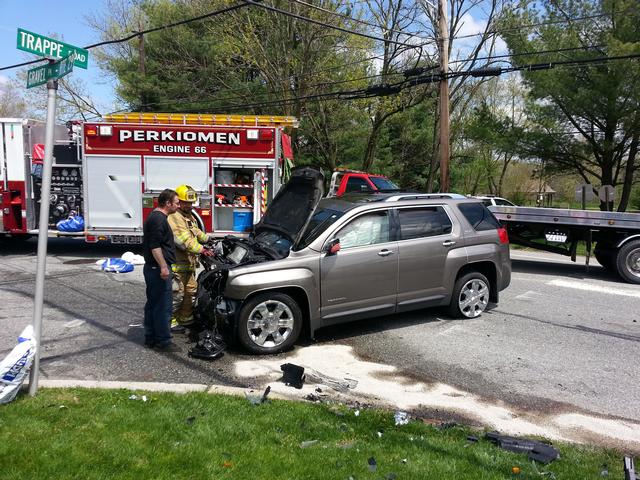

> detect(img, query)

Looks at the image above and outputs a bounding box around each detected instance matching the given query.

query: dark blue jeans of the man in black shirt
[144,265,172,345]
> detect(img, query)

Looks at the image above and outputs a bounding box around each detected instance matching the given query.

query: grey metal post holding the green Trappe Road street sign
[29,80,58,396]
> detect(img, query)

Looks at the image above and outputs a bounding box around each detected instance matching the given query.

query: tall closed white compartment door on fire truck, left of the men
[84,155,142,230]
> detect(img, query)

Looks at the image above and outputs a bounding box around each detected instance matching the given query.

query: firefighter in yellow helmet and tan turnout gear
[168,185,213,333]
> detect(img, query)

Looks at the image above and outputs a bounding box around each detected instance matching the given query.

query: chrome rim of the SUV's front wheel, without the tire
[247,300,296,348]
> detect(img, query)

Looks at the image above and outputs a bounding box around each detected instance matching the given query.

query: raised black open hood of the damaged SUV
[254,167,324,245]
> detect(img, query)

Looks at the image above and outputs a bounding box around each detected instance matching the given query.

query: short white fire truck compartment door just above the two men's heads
[144,157,209,192]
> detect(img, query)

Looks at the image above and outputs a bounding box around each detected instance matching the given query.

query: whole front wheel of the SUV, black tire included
[238,292,303,354]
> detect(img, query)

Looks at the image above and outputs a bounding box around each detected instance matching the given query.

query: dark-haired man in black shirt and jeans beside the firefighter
[142,189,180,352]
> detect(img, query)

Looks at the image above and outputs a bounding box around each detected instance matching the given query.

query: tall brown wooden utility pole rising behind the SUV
[438,0,450,192]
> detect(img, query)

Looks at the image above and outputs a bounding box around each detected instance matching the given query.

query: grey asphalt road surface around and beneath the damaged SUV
[0,239,640,443]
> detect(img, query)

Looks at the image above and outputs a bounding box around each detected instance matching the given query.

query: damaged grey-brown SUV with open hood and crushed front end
[196,167,511,354]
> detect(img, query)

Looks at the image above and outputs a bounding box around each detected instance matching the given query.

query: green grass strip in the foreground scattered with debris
[0,389,623,480]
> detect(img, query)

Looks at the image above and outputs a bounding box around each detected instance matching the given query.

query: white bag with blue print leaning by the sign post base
[0,325,36,404]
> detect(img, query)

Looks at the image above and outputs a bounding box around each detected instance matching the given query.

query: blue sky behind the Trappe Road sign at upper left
[0,0,115,113]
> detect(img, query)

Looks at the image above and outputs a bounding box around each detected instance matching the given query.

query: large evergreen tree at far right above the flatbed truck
[502,0,640,210]
